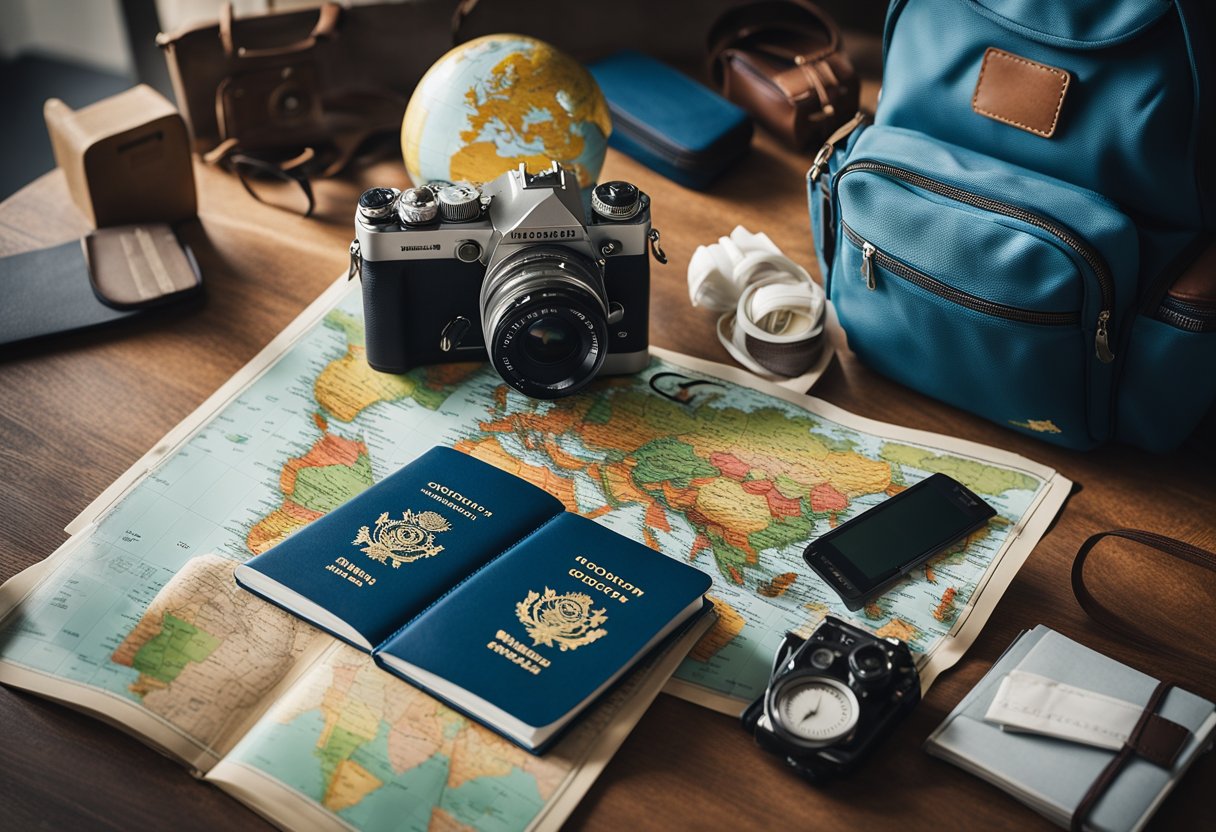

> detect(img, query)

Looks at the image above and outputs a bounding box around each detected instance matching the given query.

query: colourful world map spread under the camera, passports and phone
[0,282,1051,828]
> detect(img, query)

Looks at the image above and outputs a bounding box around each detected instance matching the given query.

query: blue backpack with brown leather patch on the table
[807,0,1216,450]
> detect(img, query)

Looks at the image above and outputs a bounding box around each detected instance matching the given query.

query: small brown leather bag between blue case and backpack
[709,0,860,150]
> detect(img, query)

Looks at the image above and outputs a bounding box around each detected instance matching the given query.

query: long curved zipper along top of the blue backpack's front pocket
[834,162,1115,364]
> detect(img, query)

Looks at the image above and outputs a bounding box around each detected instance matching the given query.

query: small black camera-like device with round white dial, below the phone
[742,615,921,781]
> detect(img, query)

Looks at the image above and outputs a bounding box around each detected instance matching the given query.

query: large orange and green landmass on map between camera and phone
[457,381,891,585]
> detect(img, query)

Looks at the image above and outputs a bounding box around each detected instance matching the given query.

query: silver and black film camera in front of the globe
[350,162,666,399]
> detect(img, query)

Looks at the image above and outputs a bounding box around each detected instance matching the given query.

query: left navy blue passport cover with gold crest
[236,448,563,651]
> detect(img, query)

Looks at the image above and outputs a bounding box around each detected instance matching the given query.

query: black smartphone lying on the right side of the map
[803,474,996,609]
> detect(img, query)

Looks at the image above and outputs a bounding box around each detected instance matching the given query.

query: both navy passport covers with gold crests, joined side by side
[236,449,711,752]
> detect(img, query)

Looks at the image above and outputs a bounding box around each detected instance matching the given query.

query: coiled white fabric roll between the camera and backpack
[688,226,827,377]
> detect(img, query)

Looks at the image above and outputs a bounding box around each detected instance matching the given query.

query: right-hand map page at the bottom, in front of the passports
[221,645,656,832]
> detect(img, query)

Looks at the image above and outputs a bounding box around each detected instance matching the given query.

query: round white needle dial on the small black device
[765,671,861,748]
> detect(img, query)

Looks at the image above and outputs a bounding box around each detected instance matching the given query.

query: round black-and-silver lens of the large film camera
[482,247,608,399]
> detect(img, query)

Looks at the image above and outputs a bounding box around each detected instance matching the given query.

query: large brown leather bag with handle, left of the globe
[157,0,451,175]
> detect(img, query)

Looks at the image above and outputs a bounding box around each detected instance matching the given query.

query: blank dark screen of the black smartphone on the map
[832,488,975,581]
